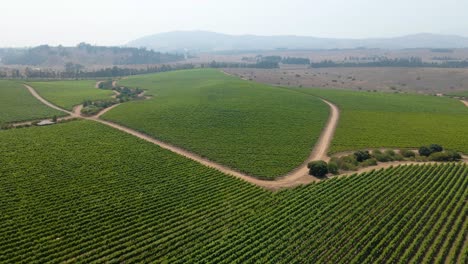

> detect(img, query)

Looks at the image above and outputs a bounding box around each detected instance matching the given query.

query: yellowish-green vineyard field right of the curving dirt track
[293,88,468,153]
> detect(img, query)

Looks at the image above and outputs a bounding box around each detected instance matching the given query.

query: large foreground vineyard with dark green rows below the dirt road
[0,121,468,263]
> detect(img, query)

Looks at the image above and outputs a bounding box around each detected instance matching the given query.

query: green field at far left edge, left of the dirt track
[0,80,63,125]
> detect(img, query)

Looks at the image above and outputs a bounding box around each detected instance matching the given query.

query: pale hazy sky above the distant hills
[0,0,468,47]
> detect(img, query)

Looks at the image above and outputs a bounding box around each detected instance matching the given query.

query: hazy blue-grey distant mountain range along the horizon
[127,31,468,51]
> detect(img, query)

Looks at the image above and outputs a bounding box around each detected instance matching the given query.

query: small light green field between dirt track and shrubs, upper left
[28,80,113,111]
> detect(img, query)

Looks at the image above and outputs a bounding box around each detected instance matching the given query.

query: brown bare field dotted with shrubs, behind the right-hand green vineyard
[225,67,468,94]
